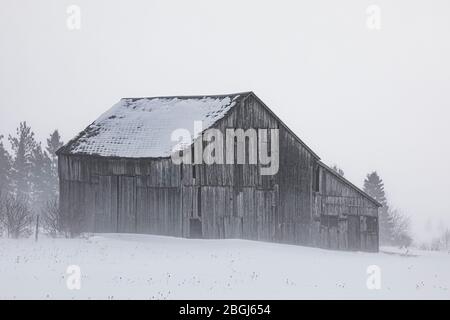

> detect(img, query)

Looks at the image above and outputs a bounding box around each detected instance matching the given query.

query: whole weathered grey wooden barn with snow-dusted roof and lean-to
[58,92,380,251]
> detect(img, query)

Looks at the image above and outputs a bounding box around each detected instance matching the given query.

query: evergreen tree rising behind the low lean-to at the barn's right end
[364,171,394,244]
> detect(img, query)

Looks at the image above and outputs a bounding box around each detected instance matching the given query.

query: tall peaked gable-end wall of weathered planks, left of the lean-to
[183,96,313,244]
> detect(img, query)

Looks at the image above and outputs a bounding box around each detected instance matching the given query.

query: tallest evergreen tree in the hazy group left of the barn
[9,122,36,202]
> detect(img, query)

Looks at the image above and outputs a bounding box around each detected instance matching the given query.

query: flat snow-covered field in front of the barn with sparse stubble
[0,234,450,299]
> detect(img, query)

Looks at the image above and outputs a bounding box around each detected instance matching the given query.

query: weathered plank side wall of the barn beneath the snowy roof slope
[59,155,183,236]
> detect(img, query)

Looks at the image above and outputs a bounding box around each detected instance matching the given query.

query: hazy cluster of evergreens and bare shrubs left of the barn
[0,122,63,238]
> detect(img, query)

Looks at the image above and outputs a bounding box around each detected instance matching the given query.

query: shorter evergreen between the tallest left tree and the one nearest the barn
[30,144,57,212]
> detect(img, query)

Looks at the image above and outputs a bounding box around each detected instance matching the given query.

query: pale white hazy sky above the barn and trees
[0,0,450,240]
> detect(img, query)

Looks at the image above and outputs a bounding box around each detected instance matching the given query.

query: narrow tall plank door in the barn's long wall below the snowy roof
[117,176,136,233]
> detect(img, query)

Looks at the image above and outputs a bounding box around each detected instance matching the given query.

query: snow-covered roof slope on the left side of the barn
[60,93,248,158]
